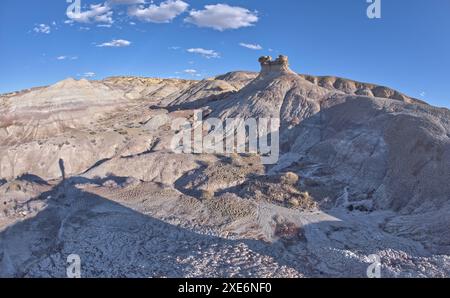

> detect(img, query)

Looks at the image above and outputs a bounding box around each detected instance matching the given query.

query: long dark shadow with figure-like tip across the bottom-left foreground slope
[0,172,324,277]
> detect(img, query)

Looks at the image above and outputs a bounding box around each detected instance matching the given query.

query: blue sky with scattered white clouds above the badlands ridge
[0,0,450,107]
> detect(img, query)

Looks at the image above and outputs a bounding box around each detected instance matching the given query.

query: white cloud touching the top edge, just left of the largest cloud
[128,0,189,23]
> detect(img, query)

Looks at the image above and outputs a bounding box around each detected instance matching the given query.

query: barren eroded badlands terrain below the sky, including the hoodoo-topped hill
[0,57,450,277]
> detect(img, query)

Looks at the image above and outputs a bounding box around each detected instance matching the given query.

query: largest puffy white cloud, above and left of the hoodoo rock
[185,4,258,31]
